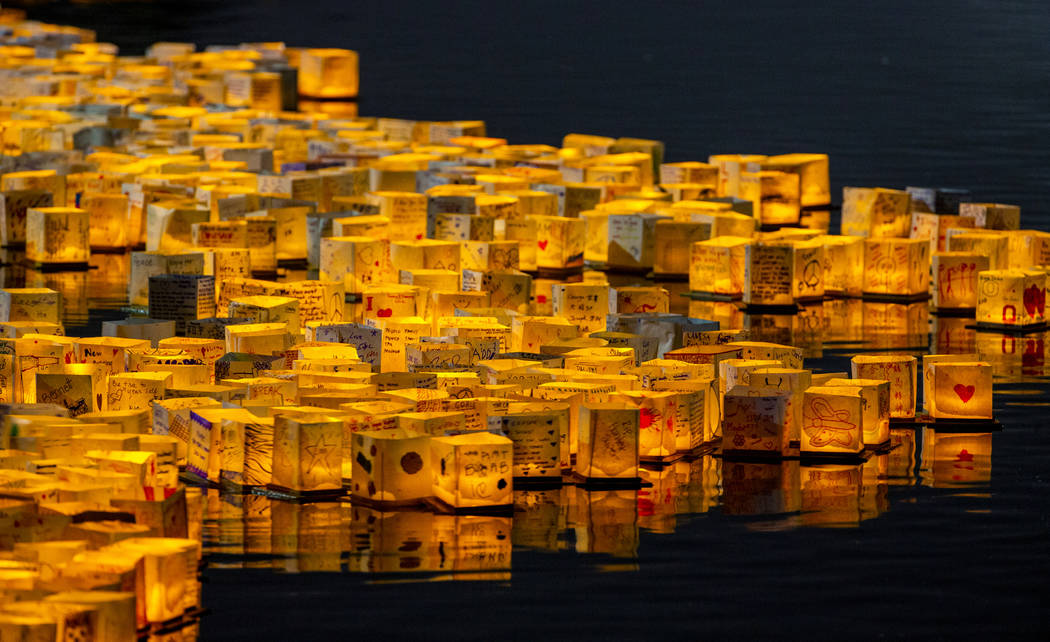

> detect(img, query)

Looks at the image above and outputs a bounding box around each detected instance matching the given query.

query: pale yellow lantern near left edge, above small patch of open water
[25,207,90,266]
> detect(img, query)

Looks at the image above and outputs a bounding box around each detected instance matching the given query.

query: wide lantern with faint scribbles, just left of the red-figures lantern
[863,239,929,297]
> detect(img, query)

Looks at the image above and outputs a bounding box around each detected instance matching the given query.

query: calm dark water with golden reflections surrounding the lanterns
[4,0,1050,640]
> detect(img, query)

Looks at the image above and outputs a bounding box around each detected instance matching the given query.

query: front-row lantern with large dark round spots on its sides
[351,429,434,506]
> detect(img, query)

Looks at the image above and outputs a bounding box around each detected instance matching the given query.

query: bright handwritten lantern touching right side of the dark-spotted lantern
[431,433,513,509]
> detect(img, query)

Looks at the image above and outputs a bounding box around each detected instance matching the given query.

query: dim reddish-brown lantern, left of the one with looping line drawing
[722,386,795,456]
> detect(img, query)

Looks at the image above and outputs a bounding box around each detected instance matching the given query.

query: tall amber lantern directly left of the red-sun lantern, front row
[573,403,639,480]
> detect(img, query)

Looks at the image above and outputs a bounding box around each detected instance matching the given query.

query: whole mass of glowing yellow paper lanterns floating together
[0,7,1007,640]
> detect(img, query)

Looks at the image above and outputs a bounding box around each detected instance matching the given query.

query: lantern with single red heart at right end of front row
[923,359,992,419]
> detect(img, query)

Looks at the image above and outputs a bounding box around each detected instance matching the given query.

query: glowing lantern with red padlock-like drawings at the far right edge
[977,270,1047,328]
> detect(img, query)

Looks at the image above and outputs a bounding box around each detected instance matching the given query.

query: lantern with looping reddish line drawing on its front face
[799,386,864,455]
